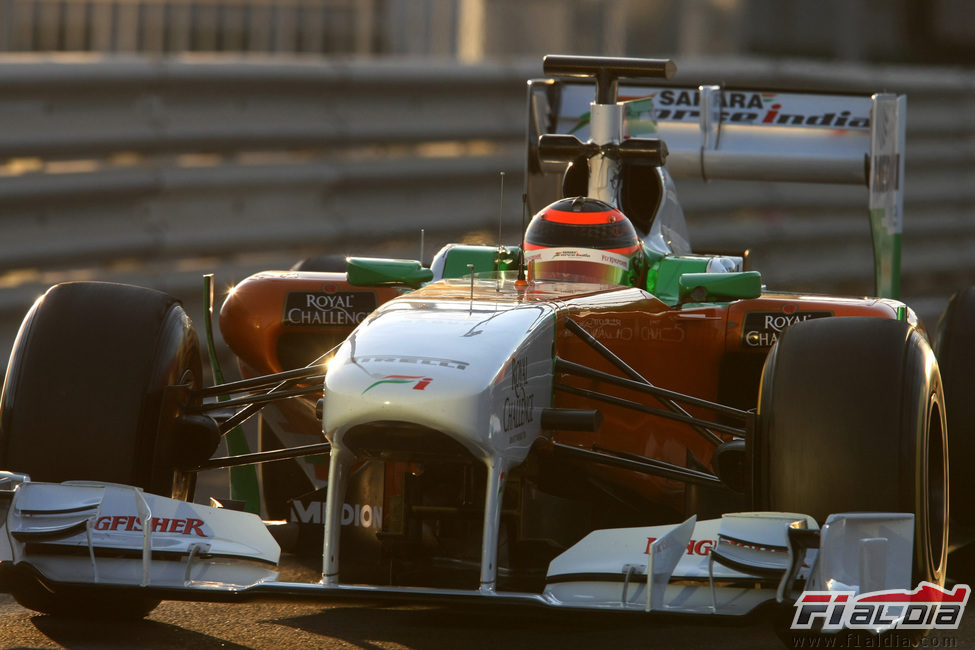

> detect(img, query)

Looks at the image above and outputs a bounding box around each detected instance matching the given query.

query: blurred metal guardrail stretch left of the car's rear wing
[0,59,527,269]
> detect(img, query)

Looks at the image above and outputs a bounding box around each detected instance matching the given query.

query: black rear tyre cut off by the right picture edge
[935,287,975,532]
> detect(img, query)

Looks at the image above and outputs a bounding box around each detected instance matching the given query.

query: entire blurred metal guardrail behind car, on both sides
[0,57,975,325]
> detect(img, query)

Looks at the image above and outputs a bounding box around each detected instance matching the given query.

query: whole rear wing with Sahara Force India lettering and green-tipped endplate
[526,79,907,298]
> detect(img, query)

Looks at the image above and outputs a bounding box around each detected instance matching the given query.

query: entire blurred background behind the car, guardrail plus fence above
[0,0,975,344]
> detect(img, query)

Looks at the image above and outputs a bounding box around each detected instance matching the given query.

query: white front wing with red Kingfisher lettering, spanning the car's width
[0,473,913,616]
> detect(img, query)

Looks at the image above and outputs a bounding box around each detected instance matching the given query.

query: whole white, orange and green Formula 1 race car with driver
[0,56,975,631]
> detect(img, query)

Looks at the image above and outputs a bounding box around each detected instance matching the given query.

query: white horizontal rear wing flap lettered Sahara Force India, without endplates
[555,83,874,185]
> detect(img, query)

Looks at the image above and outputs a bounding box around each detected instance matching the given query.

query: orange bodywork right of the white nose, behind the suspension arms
[553,294,896,511]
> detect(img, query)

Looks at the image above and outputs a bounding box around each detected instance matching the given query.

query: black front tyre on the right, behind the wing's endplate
[754,318,948,585]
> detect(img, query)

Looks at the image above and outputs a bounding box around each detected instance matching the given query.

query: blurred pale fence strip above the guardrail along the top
[0,0,975,64]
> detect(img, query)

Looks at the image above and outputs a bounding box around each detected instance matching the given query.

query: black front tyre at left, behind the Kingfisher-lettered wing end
[0,282,208,616]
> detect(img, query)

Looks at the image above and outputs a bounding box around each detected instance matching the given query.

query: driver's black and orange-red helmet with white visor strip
[524,196,643,286]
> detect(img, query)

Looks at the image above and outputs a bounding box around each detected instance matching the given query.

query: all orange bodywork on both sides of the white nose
[220,272,898,512]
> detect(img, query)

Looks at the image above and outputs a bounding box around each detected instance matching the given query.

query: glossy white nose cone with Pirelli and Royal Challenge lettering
[323,297,555,462]
